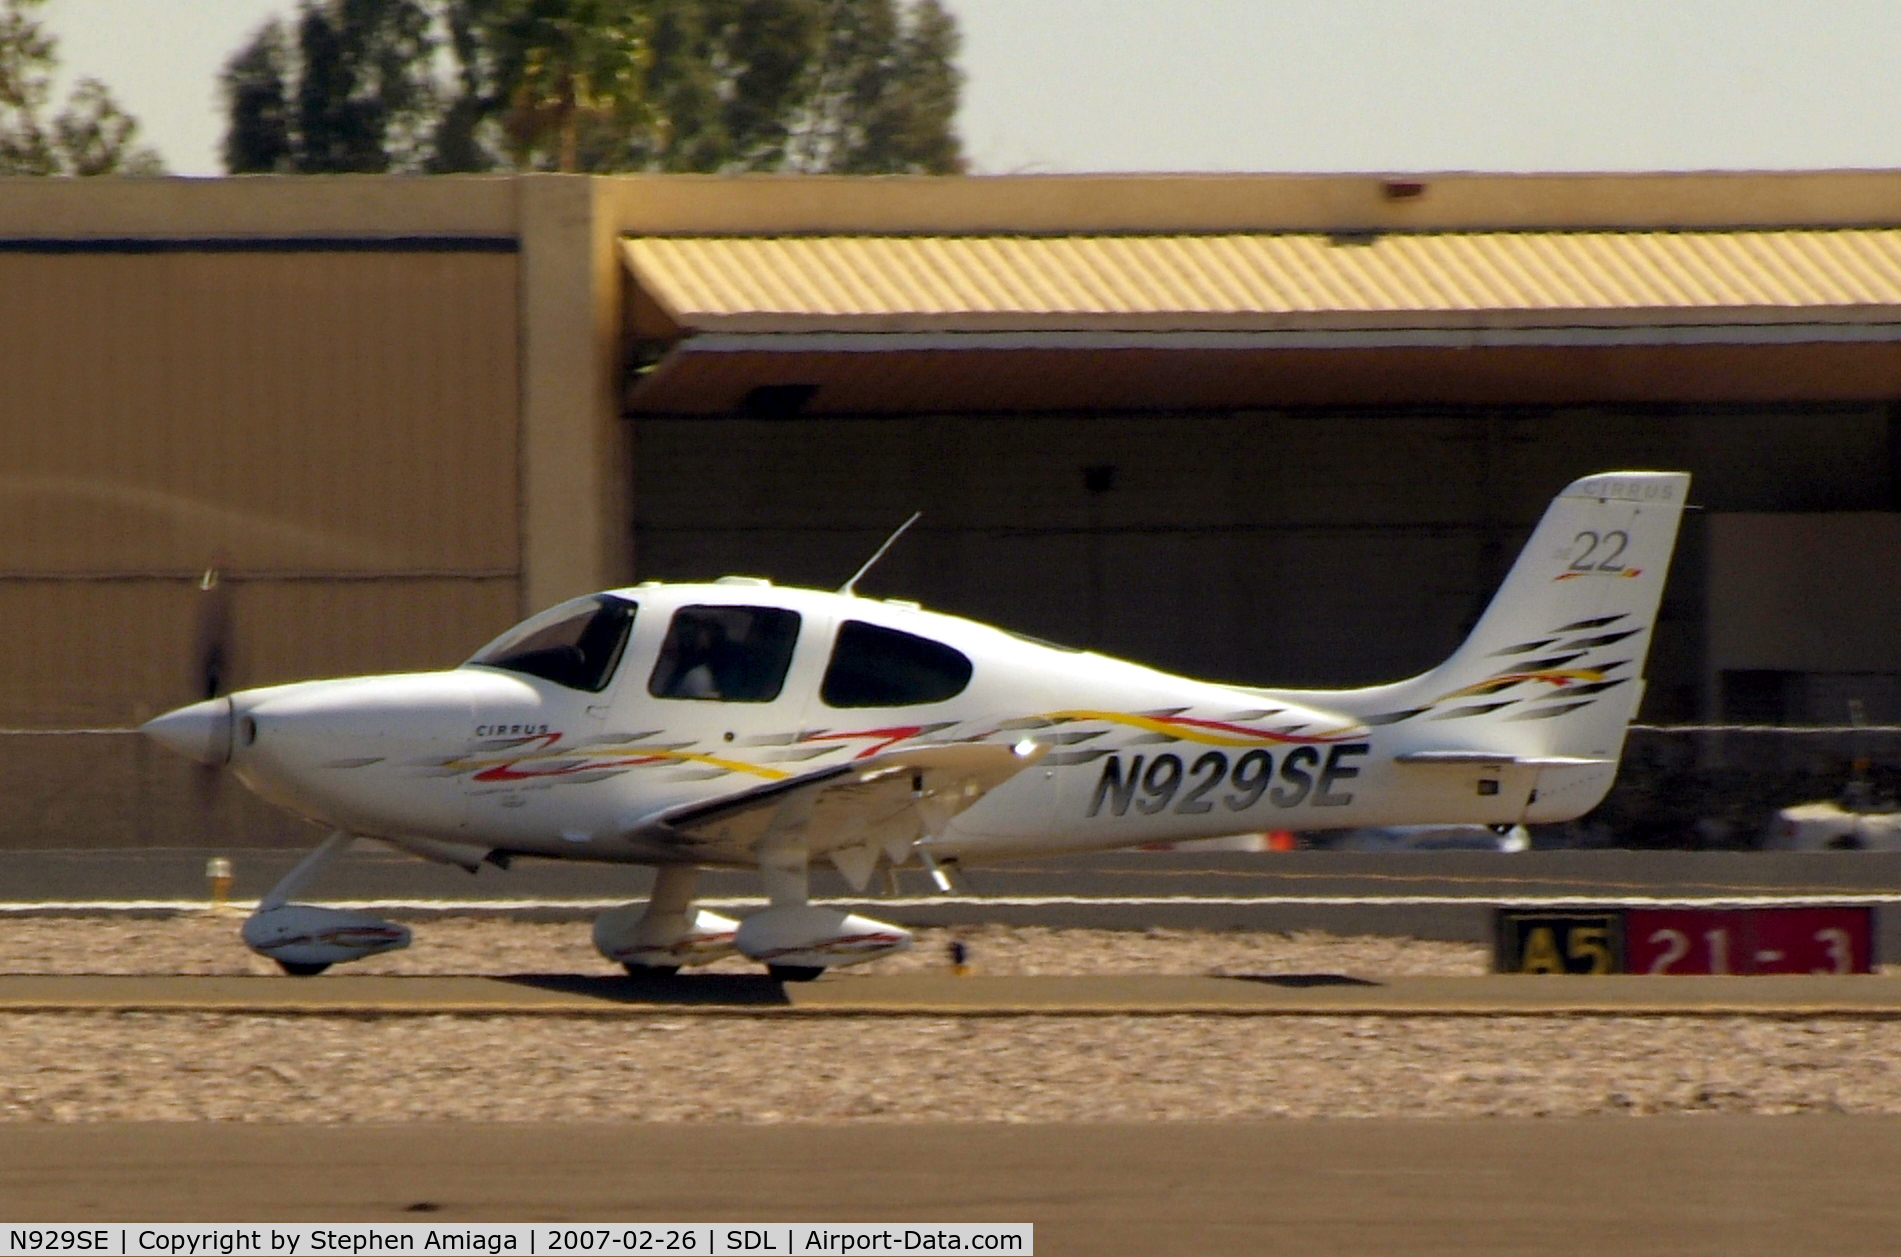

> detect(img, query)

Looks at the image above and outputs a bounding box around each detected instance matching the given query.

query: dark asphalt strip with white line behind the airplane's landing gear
[11,842,1901,943]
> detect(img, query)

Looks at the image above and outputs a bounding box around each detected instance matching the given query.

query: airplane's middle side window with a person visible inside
[646,607,798,704]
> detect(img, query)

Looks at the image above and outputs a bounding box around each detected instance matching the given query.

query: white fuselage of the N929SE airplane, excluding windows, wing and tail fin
[155,584,1619,865]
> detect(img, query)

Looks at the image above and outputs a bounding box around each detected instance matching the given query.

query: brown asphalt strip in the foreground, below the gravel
[0,1114,1901,1257]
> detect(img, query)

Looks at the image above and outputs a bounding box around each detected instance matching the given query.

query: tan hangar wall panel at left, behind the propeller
[0,251,521,726]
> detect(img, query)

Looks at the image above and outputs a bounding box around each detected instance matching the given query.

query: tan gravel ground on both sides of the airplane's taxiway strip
[0,917,1901,1122]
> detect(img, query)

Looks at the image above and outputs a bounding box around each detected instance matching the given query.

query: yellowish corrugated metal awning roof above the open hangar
[624,228,1901,331]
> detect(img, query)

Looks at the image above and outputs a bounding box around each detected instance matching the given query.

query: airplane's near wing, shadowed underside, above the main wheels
[635,742,1047,870]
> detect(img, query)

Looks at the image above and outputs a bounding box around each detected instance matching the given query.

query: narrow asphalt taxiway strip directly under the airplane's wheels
[0,974,1901,1019]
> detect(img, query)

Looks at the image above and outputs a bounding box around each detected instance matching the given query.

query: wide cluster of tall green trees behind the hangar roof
[224,0,964,173]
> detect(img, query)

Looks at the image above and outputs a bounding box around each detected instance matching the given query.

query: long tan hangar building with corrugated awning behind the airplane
[0,171,1901,846]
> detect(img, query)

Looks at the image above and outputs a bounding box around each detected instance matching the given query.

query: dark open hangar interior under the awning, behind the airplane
[631,391,1895,721]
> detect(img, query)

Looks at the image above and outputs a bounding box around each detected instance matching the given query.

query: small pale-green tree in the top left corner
[0,0,165,175]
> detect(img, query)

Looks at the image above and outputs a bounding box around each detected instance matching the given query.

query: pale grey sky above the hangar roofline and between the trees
[29,0,1901,175]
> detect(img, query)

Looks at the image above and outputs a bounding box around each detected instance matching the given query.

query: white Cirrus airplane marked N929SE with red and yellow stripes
[143,472,1690,979]
